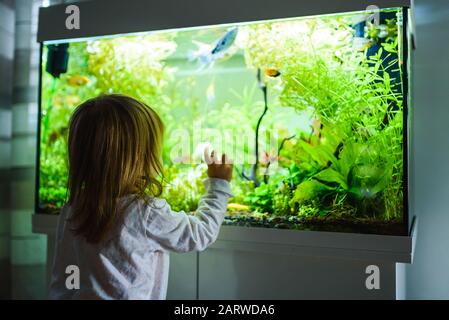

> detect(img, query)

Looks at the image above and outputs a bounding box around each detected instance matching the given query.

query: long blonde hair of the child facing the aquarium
[68,94,164,243]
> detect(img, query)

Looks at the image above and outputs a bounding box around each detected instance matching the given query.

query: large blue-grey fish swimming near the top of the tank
[189,27,238,70]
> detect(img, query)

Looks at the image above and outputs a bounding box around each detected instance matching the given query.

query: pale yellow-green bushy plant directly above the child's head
[87,33,176,105]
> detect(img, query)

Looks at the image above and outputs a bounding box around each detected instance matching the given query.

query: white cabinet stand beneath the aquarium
[33,214,418,299]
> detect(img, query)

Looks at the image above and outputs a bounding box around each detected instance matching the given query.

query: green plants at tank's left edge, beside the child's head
[39,43,99,211]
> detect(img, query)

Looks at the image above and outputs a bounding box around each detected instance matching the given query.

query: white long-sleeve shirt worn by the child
[50,178,232,299]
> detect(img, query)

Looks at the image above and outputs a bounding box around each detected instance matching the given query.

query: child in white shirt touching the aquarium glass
[50,94,232,299]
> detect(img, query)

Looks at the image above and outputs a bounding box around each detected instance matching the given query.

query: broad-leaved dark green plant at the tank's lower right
[291,144,391,220]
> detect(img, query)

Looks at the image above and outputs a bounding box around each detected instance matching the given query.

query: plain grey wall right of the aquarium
[407,0,449,299]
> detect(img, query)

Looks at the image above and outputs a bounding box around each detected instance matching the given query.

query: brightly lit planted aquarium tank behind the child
[36,8,409,235]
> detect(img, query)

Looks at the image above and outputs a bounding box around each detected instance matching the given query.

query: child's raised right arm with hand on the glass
[145,150,232,252]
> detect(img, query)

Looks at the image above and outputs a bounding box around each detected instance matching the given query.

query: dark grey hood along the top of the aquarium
[37,0,412,42]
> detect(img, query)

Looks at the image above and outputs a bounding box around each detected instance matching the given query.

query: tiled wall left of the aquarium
[0,0,89,299]
